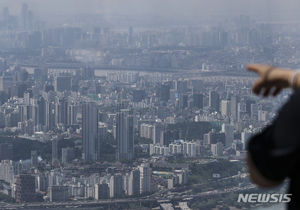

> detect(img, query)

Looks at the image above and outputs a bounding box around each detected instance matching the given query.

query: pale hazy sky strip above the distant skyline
[0,0,300,19]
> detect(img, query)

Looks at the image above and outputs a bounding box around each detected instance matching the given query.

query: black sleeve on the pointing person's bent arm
[248,90,300,181]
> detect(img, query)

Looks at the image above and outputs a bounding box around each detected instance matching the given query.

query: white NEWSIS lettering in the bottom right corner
[237,194,292,203]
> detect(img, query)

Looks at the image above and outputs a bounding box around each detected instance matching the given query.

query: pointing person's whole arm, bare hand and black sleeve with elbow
[247,69,300,188]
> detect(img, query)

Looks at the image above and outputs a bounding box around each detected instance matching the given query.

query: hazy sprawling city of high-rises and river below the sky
[0,1,300,210]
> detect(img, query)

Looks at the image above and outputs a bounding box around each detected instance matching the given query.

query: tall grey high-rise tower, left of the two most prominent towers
[82,103,100,160]
